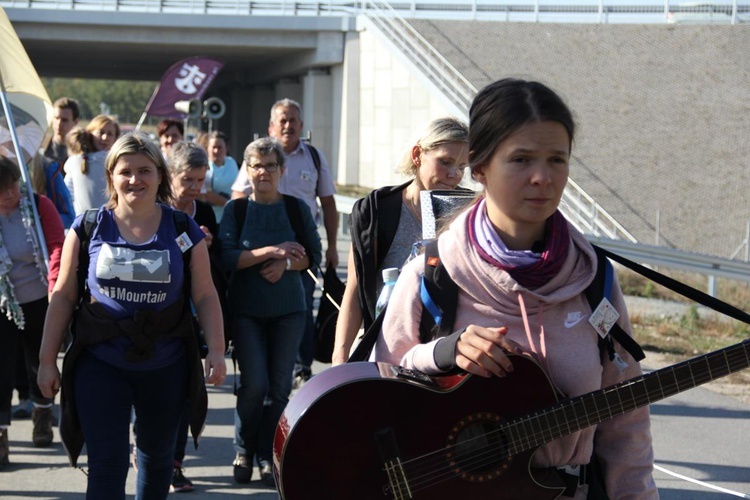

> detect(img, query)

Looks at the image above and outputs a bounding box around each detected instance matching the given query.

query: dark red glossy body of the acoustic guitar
[274,356,563,500]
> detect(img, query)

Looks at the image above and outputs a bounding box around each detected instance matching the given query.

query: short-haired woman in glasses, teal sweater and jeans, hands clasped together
[220,138,321,486]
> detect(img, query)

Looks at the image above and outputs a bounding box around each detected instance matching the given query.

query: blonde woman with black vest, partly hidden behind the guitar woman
[333,118,469,365]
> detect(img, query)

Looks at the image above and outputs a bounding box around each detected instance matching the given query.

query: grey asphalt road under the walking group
[0,230,750,500]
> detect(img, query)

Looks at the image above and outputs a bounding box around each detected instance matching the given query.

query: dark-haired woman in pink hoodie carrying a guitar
[375,79,658,499]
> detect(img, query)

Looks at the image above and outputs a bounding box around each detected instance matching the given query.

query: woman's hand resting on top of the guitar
[456,325,521,377]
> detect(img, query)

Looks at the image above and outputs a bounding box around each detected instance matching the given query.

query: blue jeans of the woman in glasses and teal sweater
[234,311,305,462]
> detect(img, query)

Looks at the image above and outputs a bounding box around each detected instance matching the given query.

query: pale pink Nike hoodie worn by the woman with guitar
[374,212,658,499]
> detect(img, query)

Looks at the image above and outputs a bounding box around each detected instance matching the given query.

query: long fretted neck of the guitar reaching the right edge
[505,340,750,454]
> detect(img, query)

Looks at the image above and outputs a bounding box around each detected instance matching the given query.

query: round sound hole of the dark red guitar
[447,413,510,482]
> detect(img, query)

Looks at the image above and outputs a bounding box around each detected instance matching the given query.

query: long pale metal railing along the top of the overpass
[0,0,750,24]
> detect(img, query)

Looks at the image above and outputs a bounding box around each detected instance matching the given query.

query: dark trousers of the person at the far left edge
[0,297,54,425]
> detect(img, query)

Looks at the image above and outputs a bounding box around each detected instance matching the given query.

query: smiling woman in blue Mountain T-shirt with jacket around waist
[37,133,226,499]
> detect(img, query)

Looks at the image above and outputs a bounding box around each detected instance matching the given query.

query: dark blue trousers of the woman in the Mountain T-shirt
[74,353,188,500]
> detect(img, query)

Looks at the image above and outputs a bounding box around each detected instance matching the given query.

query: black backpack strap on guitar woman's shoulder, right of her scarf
[584,246,646,361]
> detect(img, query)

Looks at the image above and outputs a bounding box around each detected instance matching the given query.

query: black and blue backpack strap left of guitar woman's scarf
[419,239,458,343]
